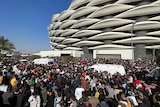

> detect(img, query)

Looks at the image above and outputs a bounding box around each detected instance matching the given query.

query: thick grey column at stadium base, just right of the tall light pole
[134,44,146,59]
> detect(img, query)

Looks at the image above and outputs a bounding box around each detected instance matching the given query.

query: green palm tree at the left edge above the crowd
[0,36,15,52]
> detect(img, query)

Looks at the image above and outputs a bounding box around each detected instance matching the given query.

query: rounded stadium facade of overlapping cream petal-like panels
[48,0,160,58]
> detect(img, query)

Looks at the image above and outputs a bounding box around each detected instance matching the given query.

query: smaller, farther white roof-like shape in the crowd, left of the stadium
[33,58,54,65]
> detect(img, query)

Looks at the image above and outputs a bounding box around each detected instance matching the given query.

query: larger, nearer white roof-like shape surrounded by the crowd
[89,64,126,75]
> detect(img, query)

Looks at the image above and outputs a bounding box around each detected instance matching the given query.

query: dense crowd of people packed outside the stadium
[0,57,160,107]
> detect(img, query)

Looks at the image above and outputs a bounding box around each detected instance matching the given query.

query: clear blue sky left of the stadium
[0,0,72,53]
